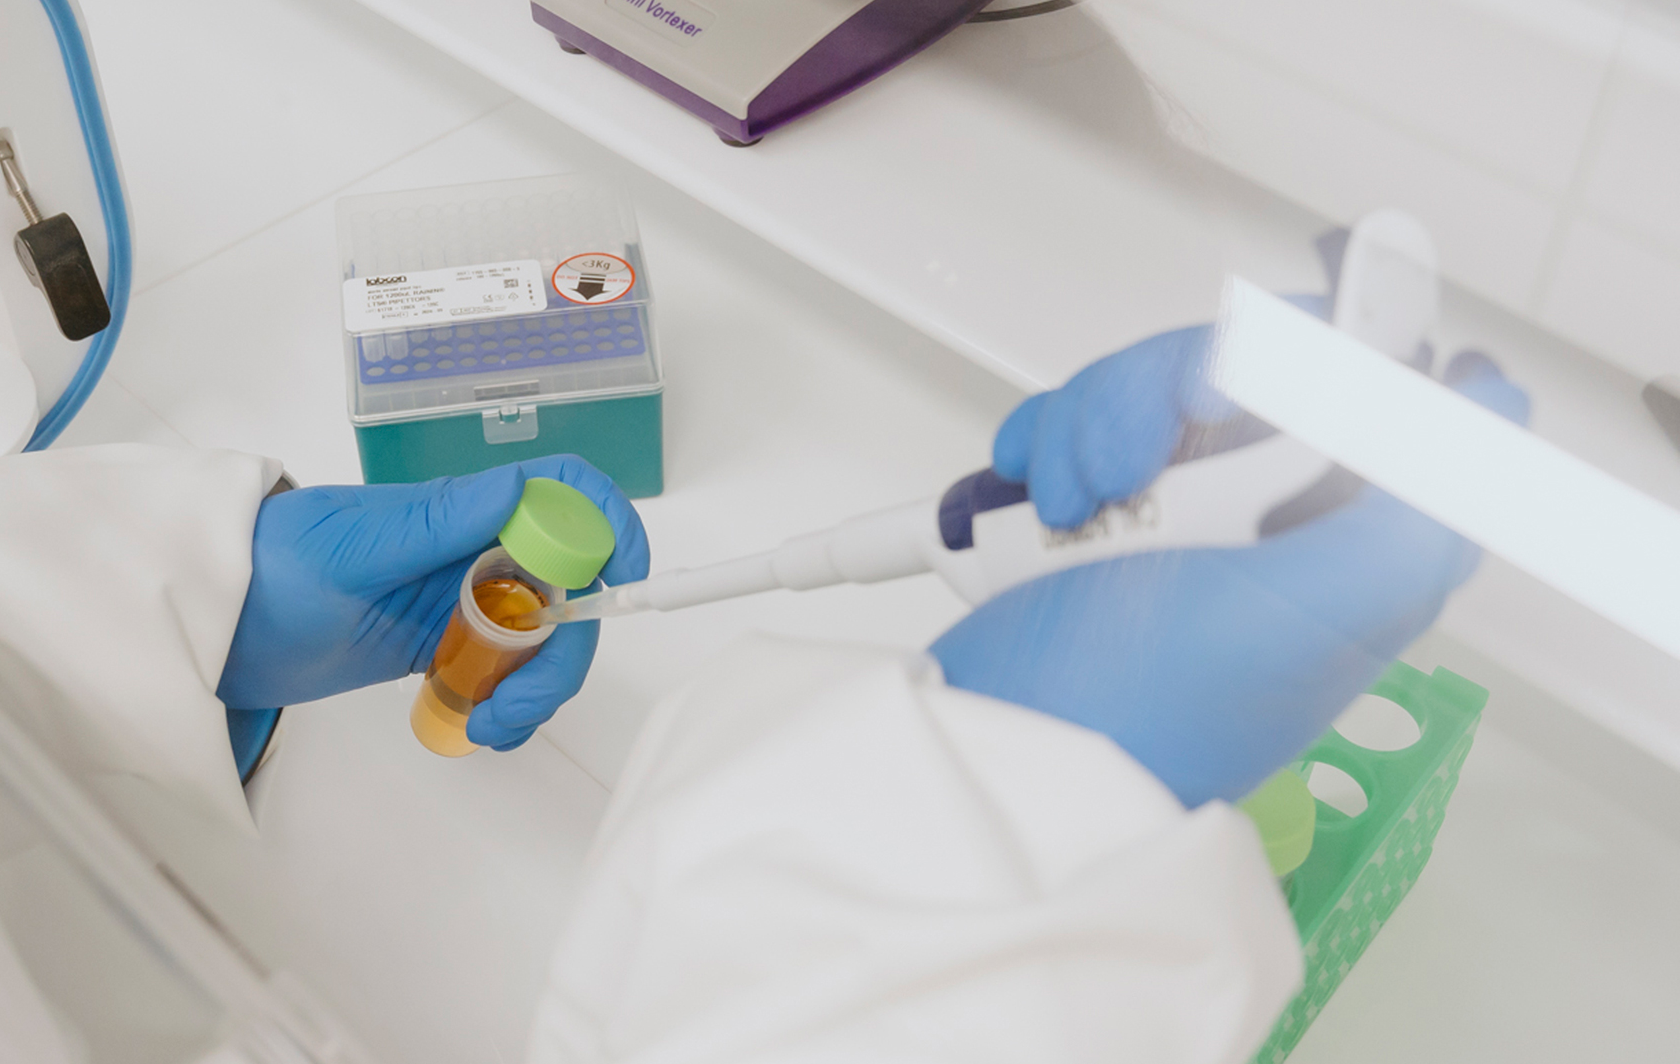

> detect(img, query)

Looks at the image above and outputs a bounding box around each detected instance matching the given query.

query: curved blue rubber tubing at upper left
[24,0,133,450]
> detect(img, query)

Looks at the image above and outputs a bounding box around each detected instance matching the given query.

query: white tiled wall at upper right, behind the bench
[1090,0,1680,377]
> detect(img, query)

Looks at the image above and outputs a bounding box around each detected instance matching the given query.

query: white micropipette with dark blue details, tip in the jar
[514,210,1438,627]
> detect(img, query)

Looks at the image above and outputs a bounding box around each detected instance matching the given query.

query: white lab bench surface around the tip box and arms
[45,0,1680,1064]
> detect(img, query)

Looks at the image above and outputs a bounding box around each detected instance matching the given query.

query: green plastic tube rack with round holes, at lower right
[1253,662,1487,1064]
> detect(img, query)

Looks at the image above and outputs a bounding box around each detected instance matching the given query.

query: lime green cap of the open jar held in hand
[501,477,618,592]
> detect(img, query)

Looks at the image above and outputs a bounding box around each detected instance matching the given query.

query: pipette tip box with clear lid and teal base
[338,175,665,498]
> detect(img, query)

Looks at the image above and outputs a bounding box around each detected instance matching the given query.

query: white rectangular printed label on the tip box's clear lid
[344,259,548,333]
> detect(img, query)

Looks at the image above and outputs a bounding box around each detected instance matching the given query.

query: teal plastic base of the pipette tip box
[356,393,665,499]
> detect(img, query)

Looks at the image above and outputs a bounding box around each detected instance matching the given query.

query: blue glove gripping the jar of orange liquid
[217,456,648,750]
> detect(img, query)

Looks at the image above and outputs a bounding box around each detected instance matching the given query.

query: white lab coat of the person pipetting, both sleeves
[0,445,1300,1064]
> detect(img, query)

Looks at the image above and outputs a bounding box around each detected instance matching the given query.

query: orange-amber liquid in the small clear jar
[408,577,548,758]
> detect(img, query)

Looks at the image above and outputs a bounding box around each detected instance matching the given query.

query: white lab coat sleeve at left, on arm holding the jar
[0,444,281,832]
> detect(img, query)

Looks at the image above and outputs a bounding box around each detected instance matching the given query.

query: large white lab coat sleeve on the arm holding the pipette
[529,637,1300,1064]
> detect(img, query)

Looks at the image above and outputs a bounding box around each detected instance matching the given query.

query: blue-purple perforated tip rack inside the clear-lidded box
[356,306,647,385]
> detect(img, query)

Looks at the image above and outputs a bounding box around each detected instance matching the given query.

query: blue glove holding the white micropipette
[932,333,1527,807]
